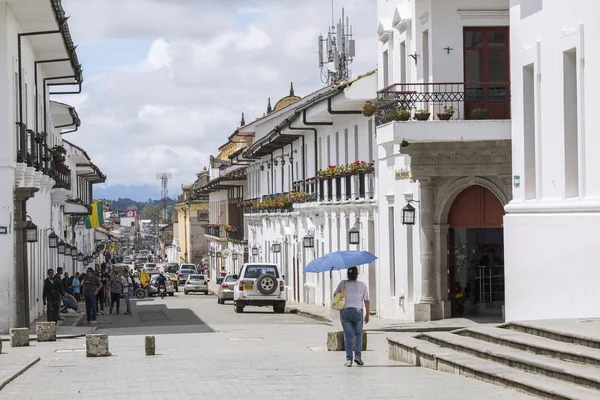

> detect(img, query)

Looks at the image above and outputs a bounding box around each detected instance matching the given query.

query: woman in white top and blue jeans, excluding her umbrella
[334,267,371,367]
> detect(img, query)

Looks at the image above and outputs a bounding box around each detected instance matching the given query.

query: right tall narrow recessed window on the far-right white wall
[563,49,579,197]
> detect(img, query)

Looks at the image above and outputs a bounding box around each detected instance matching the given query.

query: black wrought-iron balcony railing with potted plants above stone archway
[375,82,510,125]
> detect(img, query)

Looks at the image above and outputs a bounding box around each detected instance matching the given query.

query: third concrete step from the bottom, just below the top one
[453,326,600,366]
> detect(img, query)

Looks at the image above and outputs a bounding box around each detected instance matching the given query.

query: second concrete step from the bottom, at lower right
[417,332,600,390]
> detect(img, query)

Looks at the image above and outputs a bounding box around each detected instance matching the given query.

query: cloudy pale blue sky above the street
[57,0,377,197]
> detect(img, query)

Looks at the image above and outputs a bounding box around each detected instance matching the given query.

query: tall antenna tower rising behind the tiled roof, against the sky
[319,0,356,85]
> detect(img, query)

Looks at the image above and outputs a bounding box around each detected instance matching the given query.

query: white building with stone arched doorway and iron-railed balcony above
[375,0,512,321]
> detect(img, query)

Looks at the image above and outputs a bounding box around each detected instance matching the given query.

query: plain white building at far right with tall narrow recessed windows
[504,0,600,320]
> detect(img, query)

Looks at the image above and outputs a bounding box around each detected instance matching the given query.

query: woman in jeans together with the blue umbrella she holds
[304,251,377,367]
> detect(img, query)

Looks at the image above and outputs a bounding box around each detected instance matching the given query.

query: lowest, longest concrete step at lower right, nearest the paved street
[388,333,600,400]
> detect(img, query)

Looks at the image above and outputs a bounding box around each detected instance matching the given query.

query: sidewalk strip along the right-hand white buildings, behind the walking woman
[286,303,502,332]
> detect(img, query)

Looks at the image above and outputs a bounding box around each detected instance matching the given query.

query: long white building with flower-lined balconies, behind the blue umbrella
[240,71,377,309]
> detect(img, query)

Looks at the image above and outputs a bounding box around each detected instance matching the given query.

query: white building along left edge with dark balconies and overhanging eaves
[0,0,102,332]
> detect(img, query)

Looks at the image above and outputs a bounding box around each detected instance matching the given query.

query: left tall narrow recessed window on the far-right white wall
[523,64,537,200]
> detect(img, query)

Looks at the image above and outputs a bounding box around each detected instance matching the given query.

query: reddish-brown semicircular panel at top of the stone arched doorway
[448,185,504,228]
